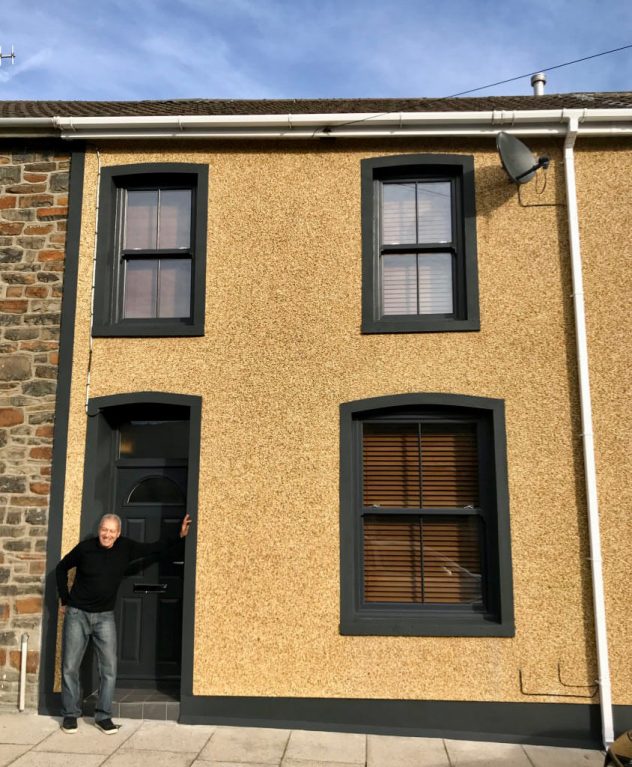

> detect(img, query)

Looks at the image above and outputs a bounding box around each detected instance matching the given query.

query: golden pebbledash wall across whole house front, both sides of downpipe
[43,139,632,740]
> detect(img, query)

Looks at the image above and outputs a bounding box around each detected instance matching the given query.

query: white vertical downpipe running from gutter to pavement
[564,118,614,748]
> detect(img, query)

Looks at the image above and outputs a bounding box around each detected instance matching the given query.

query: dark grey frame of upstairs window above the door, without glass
[92,163,208,337]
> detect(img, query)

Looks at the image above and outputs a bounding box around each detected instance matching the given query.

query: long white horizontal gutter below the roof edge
[0,109,632,140]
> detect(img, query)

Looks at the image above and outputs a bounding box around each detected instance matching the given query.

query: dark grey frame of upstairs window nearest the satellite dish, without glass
[361,154,480,333]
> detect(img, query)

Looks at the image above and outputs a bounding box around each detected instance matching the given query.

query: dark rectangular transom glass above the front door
[119,421,189,458]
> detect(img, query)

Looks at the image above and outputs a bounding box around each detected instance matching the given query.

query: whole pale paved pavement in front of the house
[0,712,604,767]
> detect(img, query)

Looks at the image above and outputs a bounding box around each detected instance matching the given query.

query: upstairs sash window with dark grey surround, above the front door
[93,163,208,336]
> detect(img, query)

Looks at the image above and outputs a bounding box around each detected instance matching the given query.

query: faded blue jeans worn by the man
[61,607,116,722]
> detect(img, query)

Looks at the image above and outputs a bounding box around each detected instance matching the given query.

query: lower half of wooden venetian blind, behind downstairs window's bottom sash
[364,515,482,604]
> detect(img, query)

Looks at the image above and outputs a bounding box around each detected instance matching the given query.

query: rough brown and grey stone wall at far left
[0,143,70,709]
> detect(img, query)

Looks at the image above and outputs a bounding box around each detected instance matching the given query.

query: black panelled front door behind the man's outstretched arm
[116,461,187,686]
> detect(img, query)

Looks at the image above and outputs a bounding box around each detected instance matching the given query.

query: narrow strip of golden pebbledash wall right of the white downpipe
[576,139,632,712]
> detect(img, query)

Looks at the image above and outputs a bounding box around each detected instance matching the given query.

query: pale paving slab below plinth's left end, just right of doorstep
[198,727,290,765]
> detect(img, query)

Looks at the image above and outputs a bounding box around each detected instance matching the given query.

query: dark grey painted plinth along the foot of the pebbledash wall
[39,693,632,748]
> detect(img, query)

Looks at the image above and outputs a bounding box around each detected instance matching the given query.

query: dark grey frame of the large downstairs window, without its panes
[340,394,515,637]
